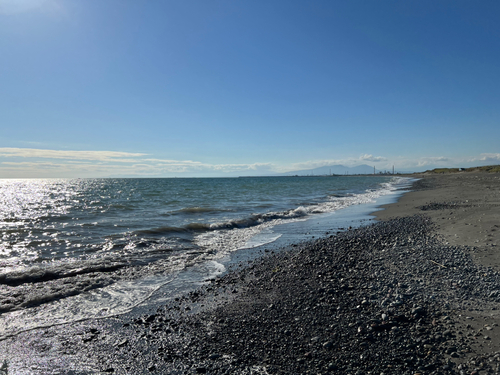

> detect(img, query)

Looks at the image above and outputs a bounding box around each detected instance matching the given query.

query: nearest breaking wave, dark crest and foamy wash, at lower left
[0,254,226,341]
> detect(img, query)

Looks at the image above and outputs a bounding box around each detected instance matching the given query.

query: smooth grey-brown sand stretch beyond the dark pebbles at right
[375,173,500,270]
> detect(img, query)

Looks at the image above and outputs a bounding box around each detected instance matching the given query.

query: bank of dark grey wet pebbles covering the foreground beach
[81,213,500,374]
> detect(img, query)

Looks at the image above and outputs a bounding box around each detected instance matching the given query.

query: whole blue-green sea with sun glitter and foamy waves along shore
[0,176,411,339]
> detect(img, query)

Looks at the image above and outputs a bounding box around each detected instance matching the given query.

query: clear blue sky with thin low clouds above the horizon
[0,0,500,178]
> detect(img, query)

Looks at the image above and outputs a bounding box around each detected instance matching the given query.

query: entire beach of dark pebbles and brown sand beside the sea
[0,173,500,374]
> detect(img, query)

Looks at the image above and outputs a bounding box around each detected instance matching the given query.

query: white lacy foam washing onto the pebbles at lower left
[0,251,226,340]
